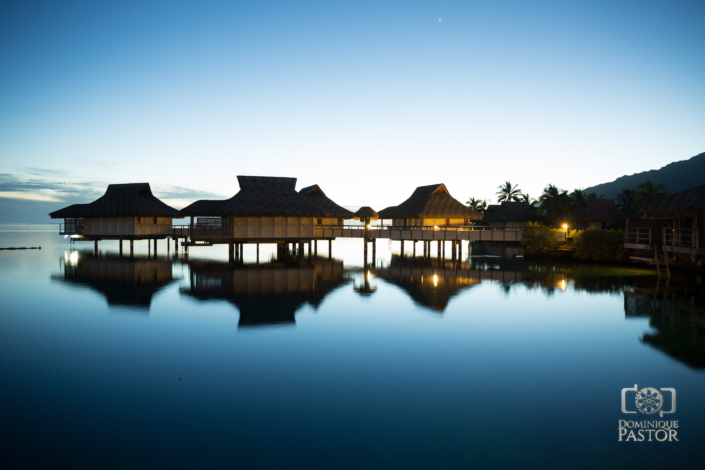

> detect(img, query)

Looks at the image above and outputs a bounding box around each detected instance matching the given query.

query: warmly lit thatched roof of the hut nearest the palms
[379,183,482,220]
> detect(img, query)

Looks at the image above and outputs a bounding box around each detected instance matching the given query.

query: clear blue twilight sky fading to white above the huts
[0,0,705,223]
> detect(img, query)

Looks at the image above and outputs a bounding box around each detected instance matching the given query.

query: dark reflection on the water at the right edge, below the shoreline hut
[624,282,705,370]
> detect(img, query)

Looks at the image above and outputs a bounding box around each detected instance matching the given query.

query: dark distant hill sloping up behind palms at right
[583,152,705,199]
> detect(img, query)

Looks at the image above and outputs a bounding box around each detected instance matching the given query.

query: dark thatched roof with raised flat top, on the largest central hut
[181,176,332,217]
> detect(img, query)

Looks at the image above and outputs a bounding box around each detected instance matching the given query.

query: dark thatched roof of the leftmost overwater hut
[49,183,180,219]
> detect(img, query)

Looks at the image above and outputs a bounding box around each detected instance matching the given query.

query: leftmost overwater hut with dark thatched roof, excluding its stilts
[49,183,180,240]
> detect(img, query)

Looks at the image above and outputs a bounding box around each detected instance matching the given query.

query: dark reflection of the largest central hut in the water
[180,258,350,327]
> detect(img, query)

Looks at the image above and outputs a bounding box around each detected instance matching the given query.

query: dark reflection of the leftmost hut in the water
[52,251,174,313]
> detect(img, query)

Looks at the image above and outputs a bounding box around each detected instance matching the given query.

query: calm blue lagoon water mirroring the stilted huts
[0,226,705,469]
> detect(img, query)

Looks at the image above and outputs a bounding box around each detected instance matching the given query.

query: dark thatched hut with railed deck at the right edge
[624,185,705,264]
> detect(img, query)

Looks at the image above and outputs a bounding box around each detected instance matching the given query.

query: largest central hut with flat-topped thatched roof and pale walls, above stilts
[181,176,352,243]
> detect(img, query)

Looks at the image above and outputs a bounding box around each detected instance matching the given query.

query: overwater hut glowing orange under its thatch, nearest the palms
[379,184,482,226]
